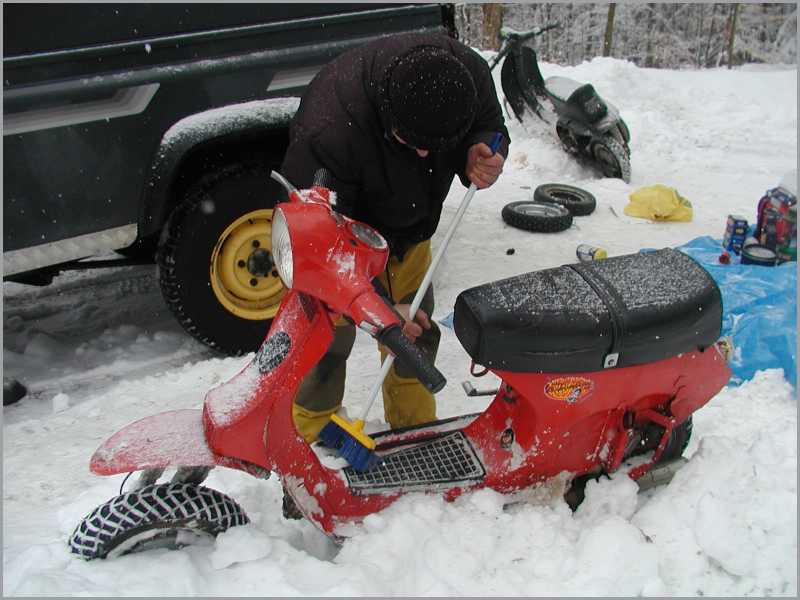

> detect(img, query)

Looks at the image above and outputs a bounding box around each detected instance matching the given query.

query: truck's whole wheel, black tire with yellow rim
[157,163,285,356]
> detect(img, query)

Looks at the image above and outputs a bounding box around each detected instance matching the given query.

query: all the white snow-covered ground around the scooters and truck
[3,58,798,596]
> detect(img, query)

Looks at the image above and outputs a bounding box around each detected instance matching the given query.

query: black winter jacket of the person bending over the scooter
[281,33,509,258]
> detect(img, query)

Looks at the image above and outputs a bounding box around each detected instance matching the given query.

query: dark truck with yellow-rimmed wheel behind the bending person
[3,3,455,355]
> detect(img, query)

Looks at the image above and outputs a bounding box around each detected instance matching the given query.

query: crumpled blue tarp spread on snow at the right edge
[677,236,797,388]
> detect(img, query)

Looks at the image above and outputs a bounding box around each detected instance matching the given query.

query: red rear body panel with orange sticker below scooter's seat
[465,347,730,491]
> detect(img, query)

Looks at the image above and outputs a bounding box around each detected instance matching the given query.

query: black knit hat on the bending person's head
[382,46,478,151]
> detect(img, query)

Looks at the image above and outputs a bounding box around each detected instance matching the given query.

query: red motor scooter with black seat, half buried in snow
[69,176,732,559]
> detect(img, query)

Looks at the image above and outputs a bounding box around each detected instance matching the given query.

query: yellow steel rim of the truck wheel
[209,209,286,321]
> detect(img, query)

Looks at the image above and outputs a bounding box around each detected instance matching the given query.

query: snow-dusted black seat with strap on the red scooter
[454,248,722,373]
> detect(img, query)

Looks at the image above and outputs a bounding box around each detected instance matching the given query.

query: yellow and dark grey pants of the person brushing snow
[292,241,441,443]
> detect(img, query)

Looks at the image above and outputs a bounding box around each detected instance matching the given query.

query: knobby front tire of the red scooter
[69,483,250,560]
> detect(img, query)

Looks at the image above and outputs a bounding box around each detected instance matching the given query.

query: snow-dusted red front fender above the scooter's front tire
[89,409,227,475]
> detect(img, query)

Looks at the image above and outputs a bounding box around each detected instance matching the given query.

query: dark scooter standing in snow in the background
[489,23,631,183]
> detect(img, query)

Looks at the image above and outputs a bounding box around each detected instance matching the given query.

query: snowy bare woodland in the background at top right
[456,0,798,68]
